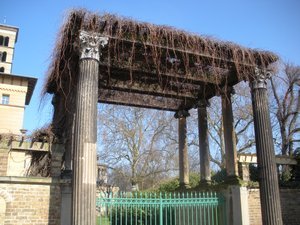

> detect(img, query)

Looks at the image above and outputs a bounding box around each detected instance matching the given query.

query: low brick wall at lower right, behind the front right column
[248,189,300,225]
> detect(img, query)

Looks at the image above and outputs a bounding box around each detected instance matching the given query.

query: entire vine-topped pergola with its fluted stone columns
[45,10,282,225]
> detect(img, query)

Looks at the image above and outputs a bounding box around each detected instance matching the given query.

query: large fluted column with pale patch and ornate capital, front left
[72,31,108,225]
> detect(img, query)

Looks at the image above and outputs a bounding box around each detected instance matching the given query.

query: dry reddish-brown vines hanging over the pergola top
[44,10,278,103]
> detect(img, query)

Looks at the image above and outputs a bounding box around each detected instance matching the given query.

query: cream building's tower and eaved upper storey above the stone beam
[0,24,37,135]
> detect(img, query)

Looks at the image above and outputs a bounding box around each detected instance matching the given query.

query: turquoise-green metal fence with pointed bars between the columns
[97,193,226,225]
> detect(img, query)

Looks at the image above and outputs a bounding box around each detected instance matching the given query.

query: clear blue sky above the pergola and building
[0,0,300,131]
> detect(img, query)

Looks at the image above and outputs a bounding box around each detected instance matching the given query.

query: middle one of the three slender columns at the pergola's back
[198,100,211,184]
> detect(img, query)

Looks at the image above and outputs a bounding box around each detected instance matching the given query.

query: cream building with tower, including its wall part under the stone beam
[0,24,37,176]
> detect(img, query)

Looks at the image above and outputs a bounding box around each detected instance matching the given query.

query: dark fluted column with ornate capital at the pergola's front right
[250,69,282,225]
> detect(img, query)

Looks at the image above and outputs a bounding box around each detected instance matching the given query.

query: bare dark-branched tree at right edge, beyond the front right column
[271,63,300,156]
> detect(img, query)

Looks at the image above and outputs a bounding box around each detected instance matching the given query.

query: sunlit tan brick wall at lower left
[0,177,61,225]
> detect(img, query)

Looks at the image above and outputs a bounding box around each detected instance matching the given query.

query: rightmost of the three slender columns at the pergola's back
[221,87,238,179]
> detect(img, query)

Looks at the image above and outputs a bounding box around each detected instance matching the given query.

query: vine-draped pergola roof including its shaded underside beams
[45,10,278,111]
